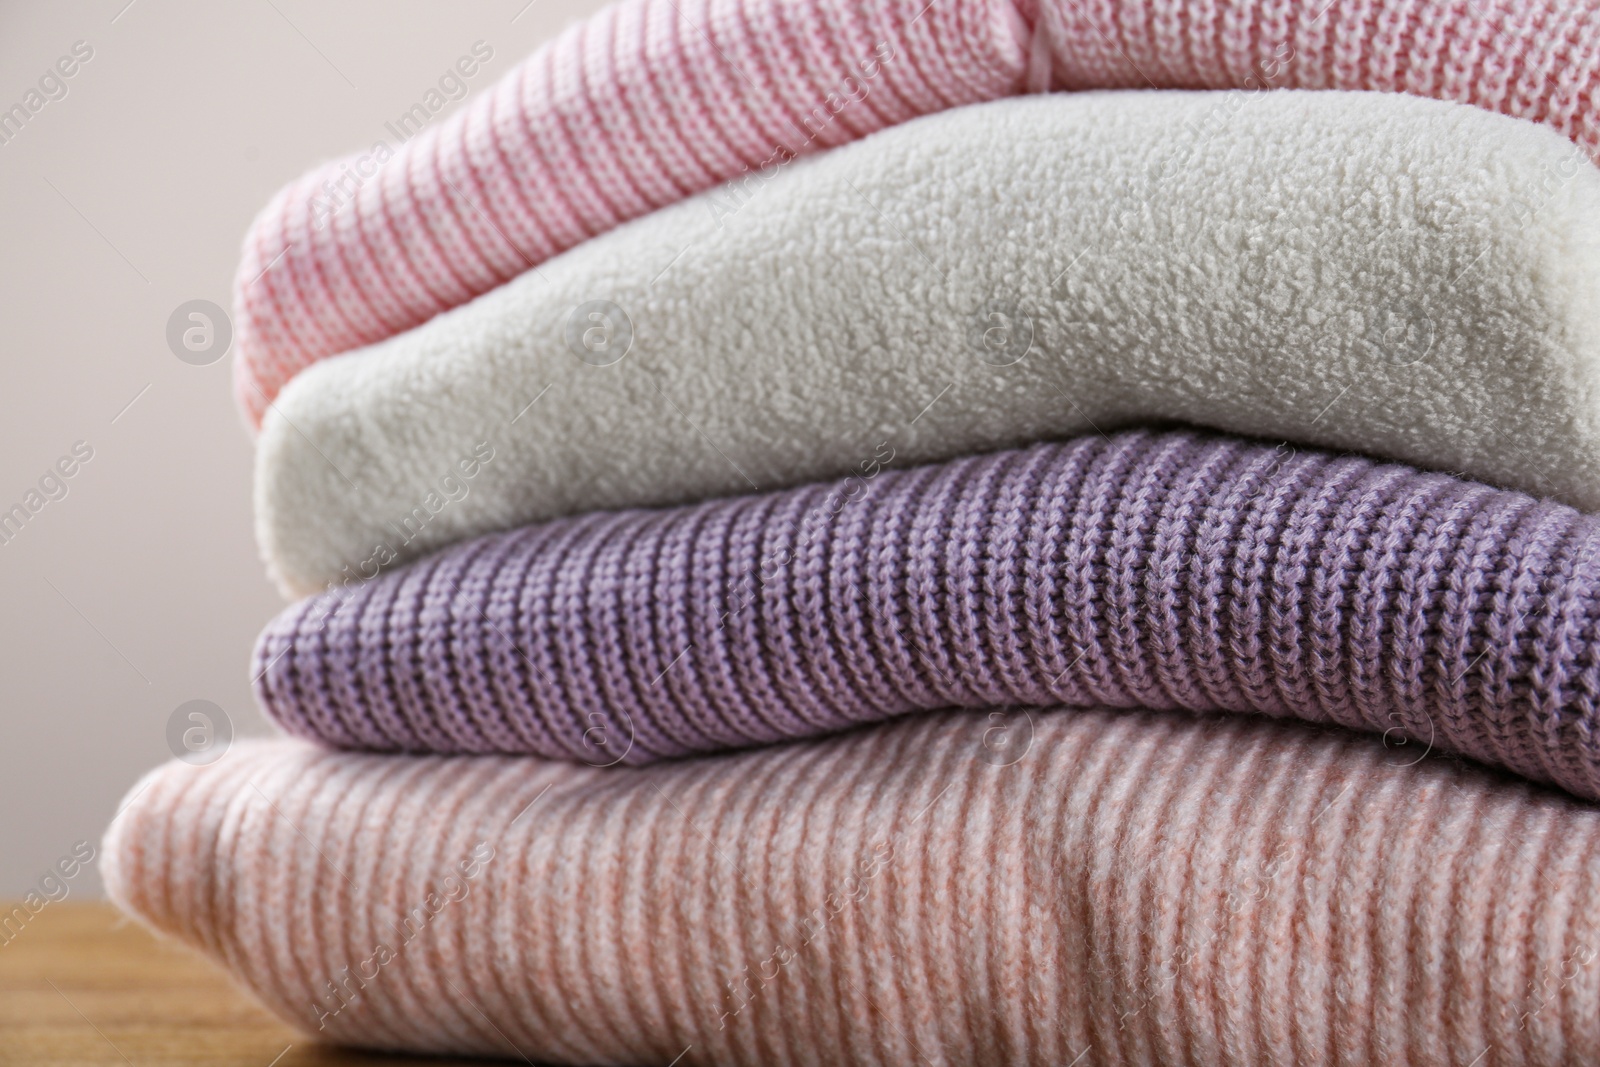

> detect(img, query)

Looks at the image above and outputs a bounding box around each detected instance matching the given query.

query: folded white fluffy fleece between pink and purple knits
[256,93,1600,593]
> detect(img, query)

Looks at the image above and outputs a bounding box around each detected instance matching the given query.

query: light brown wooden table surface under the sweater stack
[0,901,508,1067]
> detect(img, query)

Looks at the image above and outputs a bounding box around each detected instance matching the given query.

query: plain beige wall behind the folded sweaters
[0,0,602,897]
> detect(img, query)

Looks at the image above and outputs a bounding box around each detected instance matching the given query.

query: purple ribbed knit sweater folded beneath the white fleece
[256,432,1600,798]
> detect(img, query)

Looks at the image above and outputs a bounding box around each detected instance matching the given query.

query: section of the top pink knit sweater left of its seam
[234,0,1029,426]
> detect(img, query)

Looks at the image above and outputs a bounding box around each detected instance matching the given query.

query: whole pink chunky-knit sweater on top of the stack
[235,0,1600,424]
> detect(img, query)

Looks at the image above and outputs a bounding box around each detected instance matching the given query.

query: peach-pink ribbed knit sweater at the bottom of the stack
[102,710,1600,1067]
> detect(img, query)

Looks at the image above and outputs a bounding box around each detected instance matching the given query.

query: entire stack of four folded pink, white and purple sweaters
[104,0,1600,1067]
